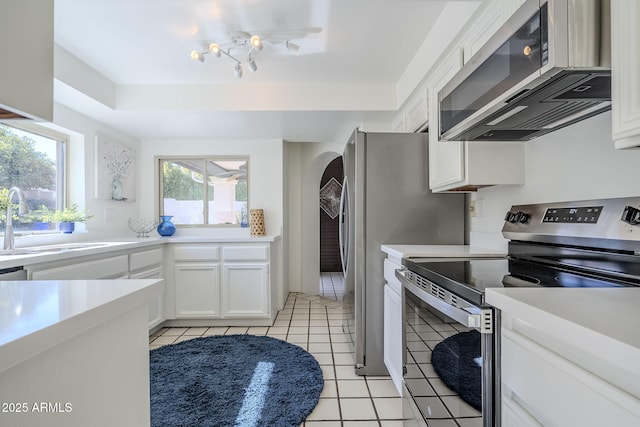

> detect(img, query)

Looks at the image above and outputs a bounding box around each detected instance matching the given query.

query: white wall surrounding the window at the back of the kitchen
[138,139,284,236]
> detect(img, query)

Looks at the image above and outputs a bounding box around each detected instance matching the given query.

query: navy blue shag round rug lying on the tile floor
[149,335,324,427]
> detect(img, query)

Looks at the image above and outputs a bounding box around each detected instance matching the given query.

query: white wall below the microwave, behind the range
[470,112,640,249]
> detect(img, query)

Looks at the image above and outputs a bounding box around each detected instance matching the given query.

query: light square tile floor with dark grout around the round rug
[149,293,402,427]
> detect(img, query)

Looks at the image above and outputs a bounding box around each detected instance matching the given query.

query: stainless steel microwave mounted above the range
[438,0,611,141]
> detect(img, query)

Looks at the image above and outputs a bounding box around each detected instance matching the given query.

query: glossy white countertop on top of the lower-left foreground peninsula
[0,279,162,372]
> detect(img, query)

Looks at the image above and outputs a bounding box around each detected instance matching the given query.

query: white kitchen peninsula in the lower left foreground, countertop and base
[0,279,162,426]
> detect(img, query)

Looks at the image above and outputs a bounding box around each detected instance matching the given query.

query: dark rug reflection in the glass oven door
[431,330,482,410]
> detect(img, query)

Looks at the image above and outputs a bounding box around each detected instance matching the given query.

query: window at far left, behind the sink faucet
[0,124,67,231]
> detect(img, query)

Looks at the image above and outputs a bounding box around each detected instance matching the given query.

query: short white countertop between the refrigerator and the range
[381,245,506,258]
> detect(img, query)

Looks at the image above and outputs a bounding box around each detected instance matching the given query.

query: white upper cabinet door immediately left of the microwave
[427,48,464,188]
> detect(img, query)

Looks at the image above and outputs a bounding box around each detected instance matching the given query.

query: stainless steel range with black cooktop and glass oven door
[397,197,640,427]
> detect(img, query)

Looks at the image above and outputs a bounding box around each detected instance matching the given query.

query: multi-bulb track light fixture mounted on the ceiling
[191,31,300,78]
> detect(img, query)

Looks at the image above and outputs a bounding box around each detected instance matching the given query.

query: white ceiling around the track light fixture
[54,0,477,142]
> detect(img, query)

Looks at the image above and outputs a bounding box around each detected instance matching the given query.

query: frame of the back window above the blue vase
[155,155,251,228]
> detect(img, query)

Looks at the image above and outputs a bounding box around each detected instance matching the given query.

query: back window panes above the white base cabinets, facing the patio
[159,157,249,226]
